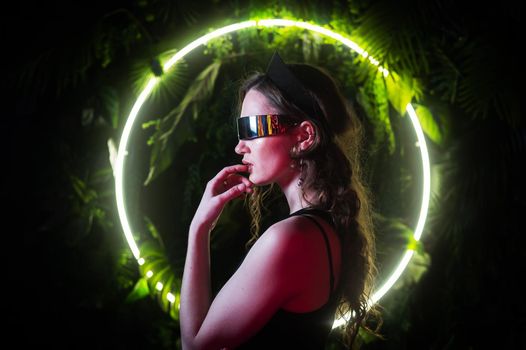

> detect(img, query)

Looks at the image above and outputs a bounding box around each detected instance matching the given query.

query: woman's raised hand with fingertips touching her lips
[191,164,253,232]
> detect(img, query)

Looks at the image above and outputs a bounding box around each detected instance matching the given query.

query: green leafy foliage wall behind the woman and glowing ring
[16,0,526,349]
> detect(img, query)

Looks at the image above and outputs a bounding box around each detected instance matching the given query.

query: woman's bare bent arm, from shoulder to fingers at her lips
[180,166,326,350]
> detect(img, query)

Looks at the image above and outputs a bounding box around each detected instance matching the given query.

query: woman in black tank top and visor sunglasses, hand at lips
[180,53,375,349]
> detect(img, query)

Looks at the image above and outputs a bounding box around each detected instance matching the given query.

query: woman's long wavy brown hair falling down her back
[239,64,378,346]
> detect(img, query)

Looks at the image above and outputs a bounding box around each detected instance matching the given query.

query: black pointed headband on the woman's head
[266,52,324,121]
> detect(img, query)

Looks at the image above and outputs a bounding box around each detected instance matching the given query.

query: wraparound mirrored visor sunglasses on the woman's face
[237,114,299,140]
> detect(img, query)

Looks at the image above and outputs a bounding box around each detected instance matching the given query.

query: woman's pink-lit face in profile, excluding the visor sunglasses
[235,89,296,187]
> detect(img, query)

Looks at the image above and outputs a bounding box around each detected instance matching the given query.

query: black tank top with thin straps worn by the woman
[238,208,339,349]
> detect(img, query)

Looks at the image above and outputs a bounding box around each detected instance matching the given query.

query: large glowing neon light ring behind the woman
[114,19,431,327]
